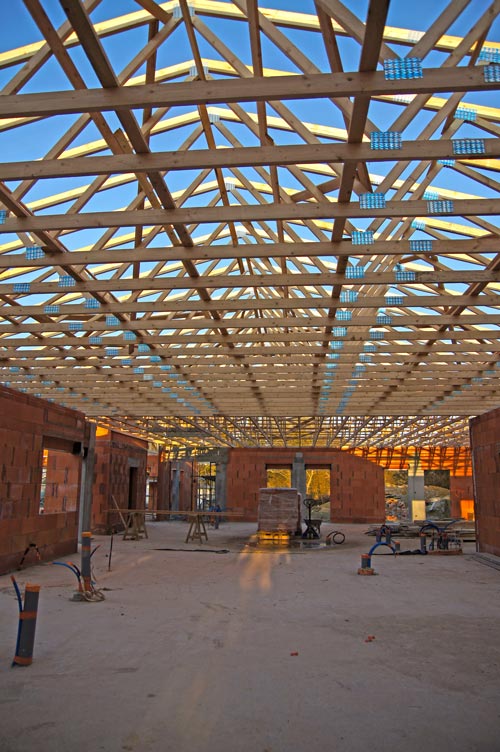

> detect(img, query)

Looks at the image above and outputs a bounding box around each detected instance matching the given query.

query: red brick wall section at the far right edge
[470,408,500,556]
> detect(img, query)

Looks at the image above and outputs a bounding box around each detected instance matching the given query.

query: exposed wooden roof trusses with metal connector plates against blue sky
[0,0,500,452]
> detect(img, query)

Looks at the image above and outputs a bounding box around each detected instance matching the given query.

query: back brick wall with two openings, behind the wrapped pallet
[226,448,385,523]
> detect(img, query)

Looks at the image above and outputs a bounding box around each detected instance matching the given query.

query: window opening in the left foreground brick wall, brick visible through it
[38,448,81,514]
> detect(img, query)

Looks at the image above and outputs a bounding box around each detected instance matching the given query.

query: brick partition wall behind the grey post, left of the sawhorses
[91,427,148,533]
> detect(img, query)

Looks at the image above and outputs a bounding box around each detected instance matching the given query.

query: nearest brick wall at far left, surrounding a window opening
[0,386,86,574]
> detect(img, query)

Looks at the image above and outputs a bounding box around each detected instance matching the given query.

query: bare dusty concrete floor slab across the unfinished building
[0,522,500,752]
